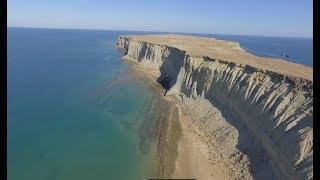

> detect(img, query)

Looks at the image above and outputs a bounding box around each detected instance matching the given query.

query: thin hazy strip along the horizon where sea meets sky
[7,26,313,39]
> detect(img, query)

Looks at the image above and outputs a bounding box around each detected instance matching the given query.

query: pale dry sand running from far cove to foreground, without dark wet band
[124,59,230,180]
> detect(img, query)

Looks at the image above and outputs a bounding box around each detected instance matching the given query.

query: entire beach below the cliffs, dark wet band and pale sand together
[122,57,231,179]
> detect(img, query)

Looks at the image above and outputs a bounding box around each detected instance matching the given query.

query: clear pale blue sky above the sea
[7,0,313,37]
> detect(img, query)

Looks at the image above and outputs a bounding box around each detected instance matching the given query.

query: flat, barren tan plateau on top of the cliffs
[125,34,313,81]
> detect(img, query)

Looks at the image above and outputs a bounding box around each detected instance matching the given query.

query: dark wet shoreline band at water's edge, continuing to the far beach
[122,58,181,178]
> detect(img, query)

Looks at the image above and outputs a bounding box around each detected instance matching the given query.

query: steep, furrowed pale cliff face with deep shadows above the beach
[117,36,313,179]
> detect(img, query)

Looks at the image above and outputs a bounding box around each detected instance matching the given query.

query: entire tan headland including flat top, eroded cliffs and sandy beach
[117,35,313,179]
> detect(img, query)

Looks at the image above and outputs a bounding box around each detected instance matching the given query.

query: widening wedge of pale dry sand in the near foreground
[173,109,230,179]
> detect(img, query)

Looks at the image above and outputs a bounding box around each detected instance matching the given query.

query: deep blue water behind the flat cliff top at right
[193,34,313,67]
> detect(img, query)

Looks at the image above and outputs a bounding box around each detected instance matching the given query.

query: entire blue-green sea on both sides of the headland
[7,27,313,180]
